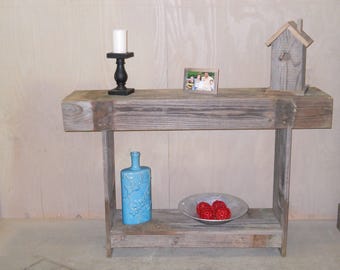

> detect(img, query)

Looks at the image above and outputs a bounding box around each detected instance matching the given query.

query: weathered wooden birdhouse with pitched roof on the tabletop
[266,20,313,95]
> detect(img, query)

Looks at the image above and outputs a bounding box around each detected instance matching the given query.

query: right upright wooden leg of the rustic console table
[273,128,292,256]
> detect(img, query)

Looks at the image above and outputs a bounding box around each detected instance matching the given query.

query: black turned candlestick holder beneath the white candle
[106,52,135,96]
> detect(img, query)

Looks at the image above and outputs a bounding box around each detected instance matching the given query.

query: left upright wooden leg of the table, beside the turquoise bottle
[102,130,116,257]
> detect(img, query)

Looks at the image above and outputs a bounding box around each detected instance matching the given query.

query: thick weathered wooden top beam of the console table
[62,88,333,131]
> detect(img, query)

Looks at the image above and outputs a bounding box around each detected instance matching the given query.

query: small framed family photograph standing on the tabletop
[183,68,218,95]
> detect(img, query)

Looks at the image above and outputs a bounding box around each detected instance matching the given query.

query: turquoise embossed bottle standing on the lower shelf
[120,152,152,225]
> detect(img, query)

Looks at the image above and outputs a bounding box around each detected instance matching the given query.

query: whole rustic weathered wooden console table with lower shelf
[62,88,333,256]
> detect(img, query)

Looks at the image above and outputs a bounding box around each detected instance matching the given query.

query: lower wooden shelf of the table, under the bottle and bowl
[111,208,283,248]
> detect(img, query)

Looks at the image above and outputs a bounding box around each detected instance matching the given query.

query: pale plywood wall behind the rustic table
[0,0,340,219]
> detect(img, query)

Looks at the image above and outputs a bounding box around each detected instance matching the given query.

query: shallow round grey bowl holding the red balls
[178,193,249,225]
